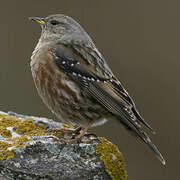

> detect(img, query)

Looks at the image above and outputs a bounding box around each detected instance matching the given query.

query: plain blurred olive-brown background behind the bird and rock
[0,0,180,180]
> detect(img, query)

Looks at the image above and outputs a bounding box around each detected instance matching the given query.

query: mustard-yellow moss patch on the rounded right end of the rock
[96,137,127,180]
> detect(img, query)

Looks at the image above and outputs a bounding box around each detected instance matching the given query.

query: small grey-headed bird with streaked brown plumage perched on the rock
[29,14,165,165]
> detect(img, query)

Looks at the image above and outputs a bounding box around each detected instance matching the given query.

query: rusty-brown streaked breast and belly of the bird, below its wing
[31,44,107,125]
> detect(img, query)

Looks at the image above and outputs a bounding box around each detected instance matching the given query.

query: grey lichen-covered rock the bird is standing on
[0,111,127,180]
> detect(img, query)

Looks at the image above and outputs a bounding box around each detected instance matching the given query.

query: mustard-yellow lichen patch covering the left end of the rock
[0,115,55,160]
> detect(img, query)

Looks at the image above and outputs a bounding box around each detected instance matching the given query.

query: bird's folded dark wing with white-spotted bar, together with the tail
[51,44,164,163]
